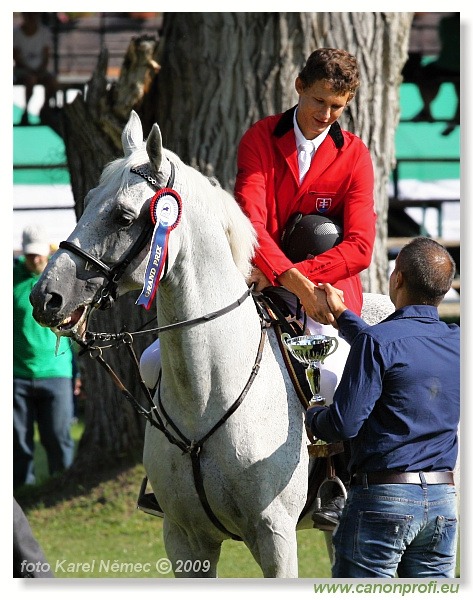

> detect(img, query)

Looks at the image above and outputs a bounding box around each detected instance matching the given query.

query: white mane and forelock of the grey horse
[100,146,256,278]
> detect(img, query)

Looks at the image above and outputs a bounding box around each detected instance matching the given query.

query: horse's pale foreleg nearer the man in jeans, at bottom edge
[246,514,298,578]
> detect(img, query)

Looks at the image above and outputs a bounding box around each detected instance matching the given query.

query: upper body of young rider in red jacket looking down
[235,48,376,323]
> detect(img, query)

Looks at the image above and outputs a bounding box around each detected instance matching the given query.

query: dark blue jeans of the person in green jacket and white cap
[13,377,74,488]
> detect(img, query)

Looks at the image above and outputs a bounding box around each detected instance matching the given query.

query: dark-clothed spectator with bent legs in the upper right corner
[412,12,460,135]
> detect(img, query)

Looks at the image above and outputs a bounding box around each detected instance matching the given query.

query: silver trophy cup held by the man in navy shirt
[281,333,338,406]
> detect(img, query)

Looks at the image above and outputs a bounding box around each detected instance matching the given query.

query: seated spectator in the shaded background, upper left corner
[13,13,58,125]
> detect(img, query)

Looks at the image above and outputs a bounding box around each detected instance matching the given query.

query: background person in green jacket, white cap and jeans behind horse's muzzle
[13,225,74,488]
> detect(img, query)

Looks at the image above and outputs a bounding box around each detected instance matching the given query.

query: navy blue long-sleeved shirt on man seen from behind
[306,305,460,473]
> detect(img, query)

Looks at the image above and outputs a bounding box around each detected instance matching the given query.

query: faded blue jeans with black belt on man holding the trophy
[332,484,457,578]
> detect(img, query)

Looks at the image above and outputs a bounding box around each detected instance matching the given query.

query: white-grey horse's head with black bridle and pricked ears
[30,112,180,338]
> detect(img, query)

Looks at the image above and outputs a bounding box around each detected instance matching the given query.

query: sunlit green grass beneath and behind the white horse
[16,423,330,578]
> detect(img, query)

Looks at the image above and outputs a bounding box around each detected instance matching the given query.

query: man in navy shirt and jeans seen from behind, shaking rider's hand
[306,237,460,578]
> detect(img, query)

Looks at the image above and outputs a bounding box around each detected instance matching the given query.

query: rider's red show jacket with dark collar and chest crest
[235,107,376,314]
